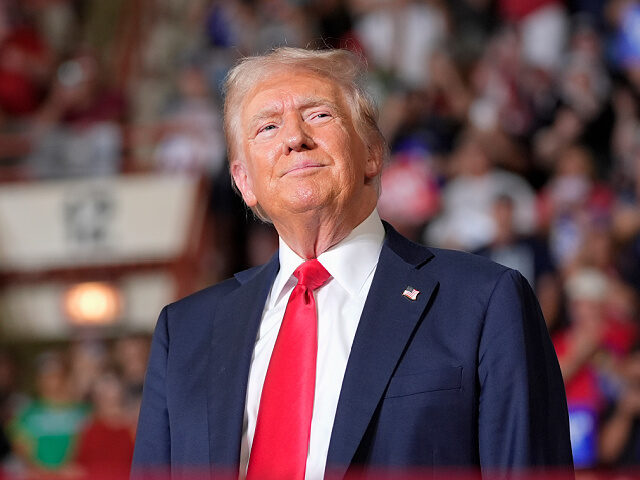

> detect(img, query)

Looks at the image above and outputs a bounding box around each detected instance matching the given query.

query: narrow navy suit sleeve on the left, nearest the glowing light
[132,307,171,478]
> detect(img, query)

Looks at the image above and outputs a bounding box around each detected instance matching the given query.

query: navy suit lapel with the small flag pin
[327,224,438,478]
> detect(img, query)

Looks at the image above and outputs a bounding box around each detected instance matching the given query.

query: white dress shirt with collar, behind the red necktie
[240,210,385,480]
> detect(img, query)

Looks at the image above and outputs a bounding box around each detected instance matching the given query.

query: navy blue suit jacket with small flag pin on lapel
[133,225,571,477]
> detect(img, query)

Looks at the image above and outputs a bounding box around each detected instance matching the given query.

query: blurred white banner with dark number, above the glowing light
[0,174,202,272]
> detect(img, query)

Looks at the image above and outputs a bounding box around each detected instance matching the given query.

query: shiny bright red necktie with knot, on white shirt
[247,259,331,480]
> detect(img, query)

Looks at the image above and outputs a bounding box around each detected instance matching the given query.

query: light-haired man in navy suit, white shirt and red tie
[133,48,571,479]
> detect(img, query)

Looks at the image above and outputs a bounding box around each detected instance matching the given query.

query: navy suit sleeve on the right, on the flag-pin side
[478,270,572,473]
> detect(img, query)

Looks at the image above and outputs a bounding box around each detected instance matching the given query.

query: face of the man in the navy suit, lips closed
[231,71,382,223]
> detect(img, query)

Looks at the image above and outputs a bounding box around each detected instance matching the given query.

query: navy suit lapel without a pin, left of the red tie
[208,254,279,473]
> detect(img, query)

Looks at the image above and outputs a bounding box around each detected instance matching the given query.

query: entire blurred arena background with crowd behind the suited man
[0,0,640,478]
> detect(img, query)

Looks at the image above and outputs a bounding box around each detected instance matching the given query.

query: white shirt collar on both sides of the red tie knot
[269,209,385,307]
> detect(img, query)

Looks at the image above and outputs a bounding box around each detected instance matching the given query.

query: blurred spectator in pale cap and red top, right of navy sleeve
[553,264,638,468]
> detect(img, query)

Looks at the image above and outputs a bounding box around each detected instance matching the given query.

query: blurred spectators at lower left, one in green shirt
[0,336,149,480]
